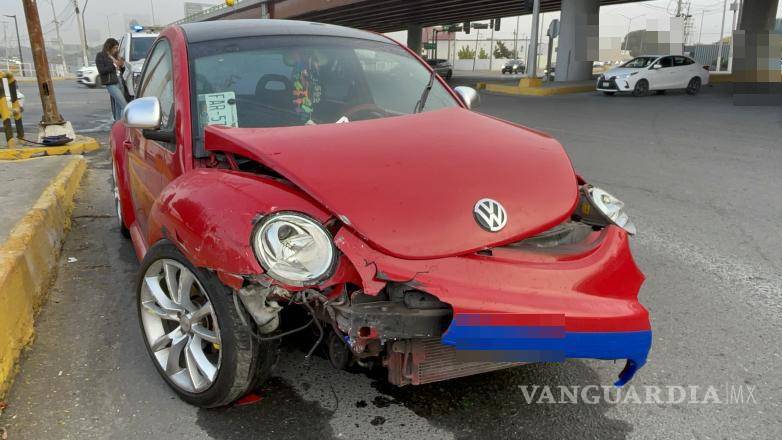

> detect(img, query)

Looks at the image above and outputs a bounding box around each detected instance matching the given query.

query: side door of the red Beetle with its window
[125,39,181,240]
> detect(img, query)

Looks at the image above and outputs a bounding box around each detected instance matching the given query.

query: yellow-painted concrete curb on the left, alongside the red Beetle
[0,156,87,399]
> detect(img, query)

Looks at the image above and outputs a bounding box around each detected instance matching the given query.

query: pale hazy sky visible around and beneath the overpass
[0,0,782,46]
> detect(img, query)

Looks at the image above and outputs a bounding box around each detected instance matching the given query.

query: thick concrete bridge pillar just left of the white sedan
[554,0,600,81]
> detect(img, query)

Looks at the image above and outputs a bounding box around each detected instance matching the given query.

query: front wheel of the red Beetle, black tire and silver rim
[136,242,276,408]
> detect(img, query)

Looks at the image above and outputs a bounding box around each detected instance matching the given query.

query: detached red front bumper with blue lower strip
[335,226,652,385]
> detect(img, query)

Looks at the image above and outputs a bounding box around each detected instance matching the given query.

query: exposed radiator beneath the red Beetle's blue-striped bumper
[387,338,523,385]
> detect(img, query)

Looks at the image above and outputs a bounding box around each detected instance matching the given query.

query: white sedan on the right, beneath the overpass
[597,55,709,96]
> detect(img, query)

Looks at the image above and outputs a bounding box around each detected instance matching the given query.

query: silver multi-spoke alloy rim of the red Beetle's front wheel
[139,259,222,393]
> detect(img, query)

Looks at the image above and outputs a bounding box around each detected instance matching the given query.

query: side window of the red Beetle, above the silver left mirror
[139,39,174,138]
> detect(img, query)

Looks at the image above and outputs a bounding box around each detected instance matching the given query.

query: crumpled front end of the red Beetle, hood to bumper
[153,112,652,385]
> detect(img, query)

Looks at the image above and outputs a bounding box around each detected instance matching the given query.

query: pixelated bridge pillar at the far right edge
[733,0,782,105]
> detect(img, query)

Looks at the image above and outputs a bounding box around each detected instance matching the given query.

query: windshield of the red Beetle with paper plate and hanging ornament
[190,36,459,140]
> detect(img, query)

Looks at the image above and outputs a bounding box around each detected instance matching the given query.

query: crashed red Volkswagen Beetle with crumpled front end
[111,20,651,407]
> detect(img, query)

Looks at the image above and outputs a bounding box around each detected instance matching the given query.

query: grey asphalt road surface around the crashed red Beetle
[0,83,782,440]
